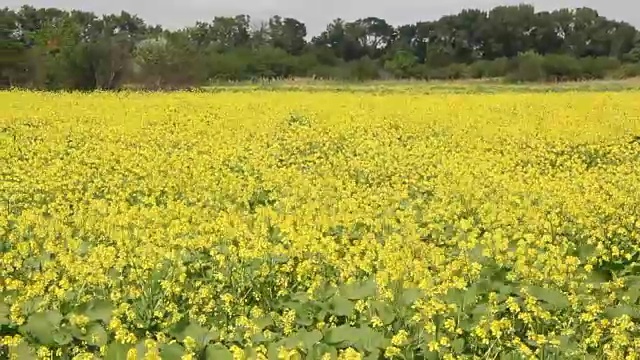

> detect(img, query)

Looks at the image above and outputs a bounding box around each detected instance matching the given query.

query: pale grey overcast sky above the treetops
[0,0,640,35]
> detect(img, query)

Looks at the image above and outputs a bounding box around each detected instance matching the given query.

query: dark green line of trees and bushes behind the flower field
[0,5,640,90]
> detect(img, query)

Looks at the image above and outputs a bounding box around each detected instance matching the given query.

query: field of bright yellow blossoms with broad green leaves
[0,91,640,359]
